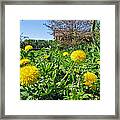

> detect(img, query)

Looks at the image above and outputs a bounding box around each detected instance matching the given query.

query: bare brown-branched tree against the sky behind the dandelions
[45,20,95,44]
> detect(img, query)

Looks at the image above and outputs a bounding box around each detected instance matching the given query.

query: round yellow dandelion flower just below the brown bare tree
[70,50,86,61]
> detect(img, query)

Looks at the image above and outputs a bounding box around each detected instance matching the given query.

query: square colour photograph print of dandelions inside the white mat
[19,20,100,100]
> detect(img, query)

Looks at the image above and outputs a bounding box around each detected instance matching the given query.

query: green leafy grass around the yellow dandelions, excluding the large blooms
[20,40,100,100]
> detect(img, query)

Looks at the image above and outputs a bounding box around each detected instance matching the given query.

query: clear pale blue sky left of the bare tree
[20,20,53,40]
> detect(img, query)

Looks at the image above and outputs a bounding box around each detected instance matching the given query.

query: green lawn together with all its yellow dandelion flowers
[20,37,100,100]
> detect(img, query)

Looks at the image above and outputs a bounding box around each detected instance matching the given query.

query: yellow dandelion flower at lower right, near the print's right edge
[84,72,97,86]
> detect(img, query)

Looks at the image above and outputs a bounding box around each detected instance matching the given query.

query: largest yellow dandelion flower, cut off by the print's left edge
[20,66,39,85]
